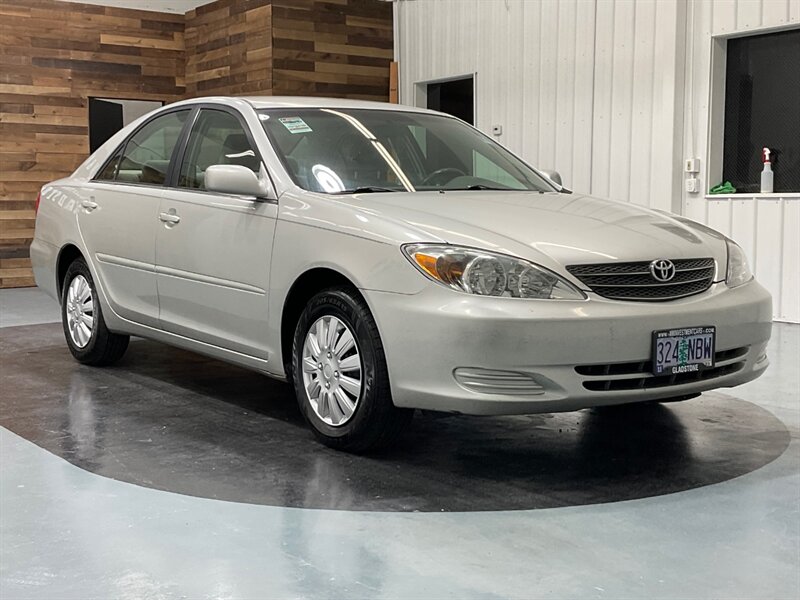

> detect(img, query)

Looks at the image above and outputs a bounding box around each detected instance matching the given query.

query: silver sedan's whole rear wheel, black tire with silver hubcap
[61,258,130,367]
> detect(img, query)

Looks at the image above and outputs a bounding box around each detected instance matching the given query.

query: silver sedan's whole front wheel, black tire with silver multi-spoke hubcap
[292,287,413,453]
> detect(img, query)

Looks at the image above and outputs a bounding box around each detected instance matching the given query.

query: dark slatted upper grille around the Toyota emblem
[567,258,717,302]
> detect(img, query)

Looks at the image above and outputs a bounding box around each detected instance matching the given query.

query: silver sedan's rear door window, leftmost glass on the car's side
[96,110,190,185]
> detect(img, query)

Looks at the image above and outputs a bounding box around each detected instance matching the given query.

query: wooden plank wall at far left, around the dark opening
[0,0,185,287]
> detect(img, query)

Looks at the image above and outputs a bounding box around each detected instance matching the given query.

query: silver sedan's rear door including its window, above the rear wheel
[78,109,191,327]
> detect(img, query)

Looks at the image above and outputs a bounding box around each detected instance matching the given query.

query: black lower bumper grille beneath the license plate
[575,346,750,392]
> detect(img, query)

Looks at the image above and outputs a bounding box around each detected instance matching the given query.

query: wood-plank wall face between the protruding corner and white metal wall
[272,0,394,102]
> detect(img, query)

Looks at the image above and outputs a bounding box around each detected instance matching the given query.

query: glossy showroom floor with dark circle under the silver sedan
[0,290,800,599]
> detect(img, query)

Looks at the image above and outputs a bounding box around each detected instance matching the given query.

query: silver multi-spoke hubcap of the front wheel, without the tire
[303,316,361,427]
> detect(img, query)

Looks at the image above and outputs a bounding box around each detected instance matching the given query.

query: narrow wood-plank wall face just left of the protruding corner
[185,0,272,97]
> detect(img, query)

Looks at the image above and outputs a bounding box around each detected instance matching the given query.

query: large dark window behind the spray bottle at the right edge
[722,29,800,192]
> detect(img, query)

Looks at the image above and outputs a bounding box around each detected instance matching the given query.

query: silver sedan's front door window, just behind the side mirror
[178,109,261,190]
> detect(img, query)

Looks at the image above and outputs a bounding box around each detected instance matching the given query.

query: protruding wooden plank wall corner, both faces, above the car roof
[186,0,394,100]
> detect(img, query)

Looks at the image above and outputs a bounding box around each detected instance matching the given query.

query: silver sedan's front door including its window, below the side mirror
[156,106,278,359]
